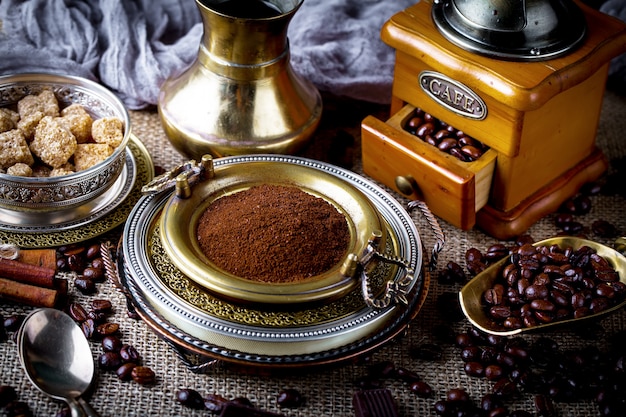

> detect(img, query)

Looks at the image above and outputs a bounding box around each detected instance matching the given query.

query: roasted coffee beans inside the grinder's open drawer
[403,109,489,162]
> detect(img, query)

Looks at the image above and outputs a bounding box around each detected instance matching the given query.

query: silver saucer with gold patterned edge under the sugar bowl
[0,135,154,248]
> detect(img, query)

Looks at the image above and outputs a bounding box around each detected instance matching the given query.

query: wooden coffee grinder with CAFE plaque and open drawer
[362,0,626,239]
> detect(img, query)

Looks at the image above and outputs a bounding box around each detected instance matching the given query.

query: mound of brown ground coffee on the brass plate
[197,184,350,283]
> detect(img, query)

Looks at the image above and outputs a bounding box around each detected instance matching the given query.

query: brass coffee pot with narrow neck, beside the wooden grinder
[158,0,322,160]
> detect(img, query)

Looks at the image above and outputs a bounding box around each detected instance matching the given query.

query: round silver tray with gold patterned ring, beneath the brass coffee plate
[118,155,429,368]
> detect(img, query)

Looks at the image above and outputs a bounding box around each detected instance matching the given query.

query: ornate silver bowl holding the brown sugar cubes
[0,73,131,211]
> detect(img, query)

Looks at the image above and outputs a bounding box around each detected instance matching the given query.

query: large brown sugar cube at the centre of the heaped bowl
[30,116,76,168]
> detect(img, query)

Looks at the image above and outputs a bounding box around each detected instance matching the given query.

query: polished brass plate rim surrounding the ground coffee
[160,160,386,304]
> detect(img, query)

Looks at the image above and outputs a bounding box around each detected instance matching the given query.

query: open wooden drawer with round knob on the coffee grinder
[361,105,497,230]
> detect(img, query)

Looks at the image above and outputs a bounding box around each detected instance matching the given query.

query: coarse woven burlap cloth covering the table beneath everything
[0,91,626,417]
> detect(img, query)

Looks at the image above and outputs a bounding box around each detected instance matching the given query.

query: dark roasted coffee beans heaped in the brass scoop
[483,244,626,329]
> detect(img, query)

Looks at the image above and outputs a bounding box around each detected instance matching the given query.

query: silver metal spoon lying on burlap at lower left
[17,308,99,417]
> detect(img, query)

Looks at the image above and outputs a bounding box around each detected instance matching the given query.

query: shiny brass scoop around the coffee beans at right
[459,237,626,336]
